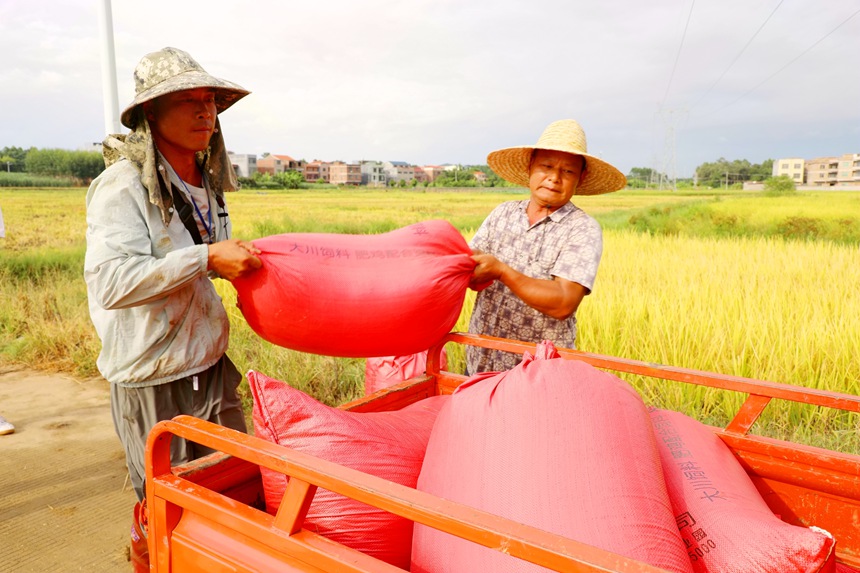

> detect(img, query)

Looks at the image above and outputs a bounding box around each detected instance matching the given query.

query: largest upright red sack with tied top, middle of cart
[411,344,692,573]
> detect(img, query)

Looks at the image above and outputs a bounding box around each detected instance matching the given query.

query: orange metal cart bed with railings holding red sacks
[146,333,860,573]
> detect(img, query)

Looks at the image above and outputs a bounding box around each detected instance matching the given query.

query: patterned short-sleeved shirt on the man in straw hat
[467,199,603,374]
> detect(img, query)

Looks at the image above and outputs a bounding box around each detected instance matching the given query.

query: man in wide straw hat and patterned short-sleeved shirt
[467,119,627,374]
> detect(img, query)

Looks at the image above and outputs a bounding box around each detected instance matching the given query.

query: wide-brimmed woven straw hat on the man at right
[487,119,627,195]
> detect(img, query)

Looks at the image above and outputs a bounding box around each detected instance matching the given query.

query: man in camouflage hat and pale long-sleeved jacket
[84,44,261,567]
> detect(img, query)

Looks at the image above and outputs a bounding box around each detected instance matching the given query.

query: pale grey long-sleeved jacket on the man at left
[84,124,235,387]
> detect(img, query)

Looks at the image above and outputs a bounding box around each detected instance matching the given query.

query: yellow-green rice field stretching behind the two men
[0,189,860,453]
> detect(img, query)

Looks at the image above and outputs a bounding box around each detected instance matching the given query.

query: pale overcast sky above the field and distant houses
[0,0,860,177]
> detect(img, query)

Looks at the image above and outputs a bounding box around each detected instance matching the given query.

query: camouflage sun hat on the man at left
[120,48,251,129]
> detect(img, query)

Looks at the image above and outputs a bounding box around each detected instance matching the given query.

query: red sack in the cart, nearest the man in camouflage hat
[248,371,450,569]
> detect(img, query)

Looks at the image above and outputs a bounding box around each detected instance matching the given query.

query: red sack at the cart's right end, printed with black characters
[651,409,835,573]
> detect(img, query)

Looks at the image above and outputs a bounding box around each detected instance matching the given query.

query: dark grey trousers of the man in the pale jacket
[110,354,248,500]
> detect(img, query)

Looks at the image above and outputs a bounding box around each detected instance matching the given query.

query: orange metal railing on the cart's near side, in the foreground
[146,416,665,573]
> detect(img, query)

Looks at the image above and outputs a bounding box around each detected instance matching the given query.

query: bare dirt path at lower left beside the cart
[0,367,136,573]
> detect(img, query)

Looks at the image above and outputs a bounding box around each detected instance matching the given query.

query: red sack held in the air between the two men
[233,220,475,358]
